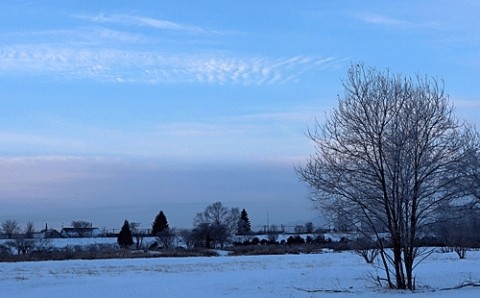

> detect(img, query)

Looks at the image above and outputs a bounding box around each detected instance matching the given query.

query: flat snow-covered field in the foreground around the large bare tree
[0,252,480,298]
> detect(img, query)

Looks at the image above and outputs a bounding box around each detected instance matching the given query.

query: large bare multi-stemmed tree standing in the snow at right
[297,64,479,290]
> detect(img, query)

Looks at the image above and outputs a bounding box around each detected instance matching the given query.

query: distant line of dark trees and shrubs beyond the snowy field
[0,202,480,263]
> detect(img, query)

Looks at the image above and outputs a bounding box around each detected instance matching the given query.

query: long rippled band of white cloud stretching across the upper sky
[0,45,338,85]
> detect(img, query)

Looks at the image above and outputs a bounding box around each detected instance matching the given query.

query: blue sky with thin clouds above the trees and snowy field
[0,0,480,228]
